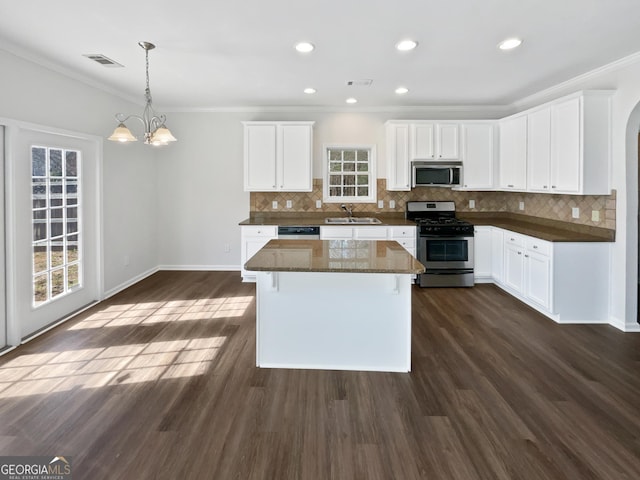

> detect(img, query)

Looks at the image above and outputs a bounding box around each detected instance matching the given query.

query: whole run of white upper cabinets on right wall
[500,90,613,195]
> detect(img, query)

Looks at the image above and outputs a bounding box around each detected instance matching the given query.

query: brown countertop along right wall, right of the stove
[457,212,616,242]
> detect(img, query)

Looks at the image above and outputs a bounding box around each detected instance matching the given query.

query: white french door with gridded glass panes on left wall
[6,126,102,345]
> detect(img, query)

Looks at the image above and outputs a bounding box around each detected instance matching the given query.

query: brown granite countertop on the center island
[244,240,424,275]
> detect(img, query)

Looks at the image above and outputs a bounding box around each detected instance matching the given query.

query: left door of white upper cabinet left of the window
[244,124,277,192]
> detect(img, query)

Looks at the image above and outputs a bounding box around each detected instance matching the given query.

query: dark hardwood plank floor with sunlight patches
[0,272,640,480]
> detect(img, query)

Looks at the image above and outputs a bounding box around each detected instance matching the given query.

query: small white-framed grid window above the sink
[324,145,376,203]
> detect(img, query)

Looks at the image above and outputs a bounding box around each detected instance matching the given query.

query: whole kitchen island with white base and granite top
[245,240,424,372]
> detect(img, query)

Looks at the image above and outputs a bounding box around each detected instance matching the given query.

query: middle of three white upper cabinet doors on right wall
[527,108,551,192]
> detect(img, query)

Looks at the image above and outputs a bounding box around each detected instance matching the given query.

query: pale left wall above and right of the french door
[0,49,158,292]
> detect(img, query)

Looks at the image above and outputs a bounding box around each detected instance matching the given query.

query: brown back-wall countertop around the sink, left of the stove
[240,212,415,227]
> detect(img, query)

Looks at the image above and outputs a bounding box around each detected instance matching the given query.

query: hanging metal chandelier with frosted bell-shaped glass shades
[109,42,176,145]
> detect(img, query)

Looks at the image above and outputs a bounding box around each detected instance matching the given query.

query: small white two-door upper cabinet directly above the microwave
[411,123,460,161]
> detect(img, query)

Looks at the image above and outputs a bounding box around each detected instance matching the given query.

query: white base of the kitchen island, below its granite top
[256,272,411,372]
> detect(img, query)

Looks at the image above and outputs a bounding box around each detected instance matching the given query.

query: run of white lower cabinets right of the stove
[476,227,610,323]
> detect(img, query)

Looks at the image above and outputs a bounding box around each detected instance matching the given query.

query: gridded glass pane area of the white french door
[31,146,82,306]
